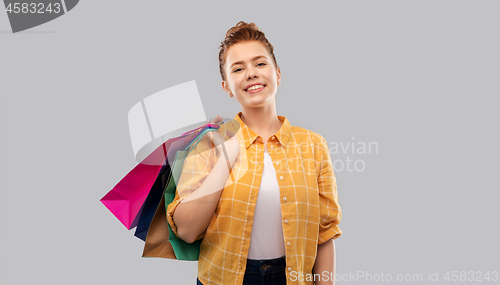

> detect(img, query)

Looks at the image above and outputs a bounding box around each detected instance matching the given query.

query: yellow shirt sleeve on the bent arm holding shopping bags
[167,132,215,240]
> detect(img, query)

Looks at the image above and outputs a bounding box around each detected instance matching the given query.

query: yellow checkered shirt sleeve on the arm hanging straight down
[318,137,342,245]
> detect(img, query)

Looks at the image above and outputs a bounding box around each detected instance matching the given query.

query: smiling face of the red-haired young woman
[222,41,281,107]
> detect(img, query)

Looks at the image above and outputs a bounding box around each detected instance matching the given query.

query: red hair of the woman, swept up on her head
[219,21,278,81]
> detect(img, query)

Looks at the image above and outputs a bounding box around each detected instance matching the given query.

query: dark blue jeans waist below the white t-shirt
[196,255,286,285]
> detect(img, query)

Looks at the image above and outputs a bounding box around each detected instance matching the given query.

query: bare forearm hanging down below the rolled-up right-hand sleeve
[313,238,335,285]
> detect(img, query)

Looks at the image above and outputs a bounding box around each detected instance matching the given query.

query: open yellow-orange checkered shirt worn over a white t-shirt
[167,112,342,285]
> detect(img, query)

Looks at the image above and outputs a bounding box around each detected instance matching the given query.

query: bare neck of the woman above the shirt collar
[241,105,282,142]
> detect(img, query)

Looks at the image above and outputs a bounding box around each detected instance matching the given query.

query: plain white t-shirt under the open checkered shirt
[248,152,285,259]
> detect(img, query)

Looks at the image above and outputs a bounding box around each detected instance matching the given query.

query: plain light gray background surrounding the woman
[0,0,500,285]
